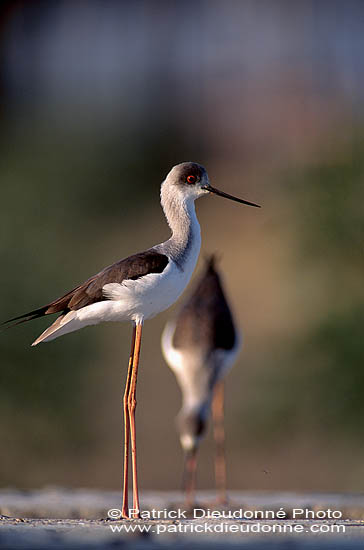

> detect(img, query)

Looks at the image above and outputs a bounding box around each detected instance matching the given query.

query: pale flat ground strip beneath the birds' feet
[0,489,364,550]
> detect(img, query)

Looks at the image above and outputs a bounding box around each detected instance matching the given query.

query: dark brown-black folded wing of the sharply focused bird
[1,250,168,326]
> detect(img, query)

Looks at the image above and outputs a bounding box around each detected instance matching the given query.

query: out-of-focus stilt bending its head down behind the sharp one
[162,254,241,508]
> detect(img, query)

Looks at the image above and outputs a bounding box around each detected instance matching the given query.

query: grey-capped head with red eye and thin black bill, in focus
[164,162,260,208]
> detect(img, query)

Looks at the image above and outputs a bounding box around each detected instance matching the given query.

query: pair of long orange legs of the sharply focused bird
[128,323,143,518]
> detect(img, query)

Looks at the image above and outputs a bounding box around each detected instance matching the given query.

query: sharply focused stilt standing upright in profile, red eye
[3,162,259,519]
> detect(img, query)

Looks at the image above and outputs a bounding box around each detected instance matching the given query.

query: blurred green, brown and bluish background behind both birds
[0,0,364,498]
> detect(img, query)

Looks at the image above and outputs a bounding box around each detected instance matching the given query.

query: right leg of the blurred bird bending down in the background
[212,380,227,504]
